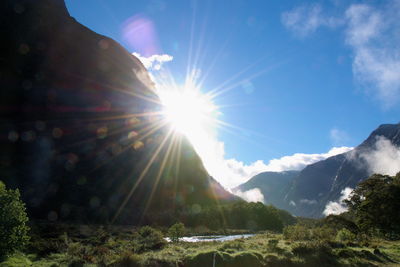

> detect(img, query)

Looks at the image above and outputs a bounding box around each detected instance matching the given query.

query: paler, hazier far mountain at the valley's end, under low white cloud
[233,171,300,208]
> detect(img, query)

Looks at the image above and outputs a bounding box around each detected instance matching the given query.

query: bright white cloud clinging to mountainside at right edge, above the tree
[360,136,400,176]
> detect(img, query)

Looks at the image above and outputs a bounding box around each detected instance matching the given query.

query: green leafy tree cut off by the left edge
[0,181,29,257]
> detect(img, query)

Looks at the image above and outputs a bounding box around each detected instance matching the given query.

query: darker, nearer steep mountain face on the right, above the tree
[284,124,400,217]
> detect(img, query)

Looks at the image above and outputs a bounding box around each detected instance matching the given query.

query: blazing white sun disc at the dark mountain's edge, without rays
[159,84,218,146]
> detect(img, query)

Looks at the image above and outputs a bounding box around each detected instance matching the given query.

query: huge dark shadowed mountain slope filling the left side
[0,0,236,226]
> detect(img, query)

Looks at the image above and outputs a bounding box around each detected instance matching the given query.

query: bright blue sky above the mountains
[66,0,400,188]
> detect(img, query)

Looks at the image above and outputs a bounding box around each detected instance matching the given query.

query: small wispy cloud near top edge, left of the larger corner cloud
[281,4,342,37]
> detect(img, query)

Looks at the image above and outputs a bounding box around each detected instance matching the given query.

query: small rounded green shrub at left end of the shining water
[135,226,166,252]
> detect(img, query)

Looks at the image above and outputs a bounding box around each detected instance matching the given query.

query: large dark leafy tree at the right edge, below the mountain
[346,173,400,238]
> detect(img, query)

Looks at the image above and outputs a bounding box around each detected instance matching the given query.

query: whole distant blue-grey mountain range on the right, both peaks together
[235,123,400,218]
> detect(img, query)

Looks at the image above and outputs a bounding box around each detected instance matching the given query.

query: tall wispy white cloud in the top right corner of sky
[345,1,400,107]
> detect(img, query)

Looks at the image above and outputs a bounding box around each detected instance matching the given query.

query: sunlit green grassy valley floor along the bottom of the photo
[0,226,400,267]
